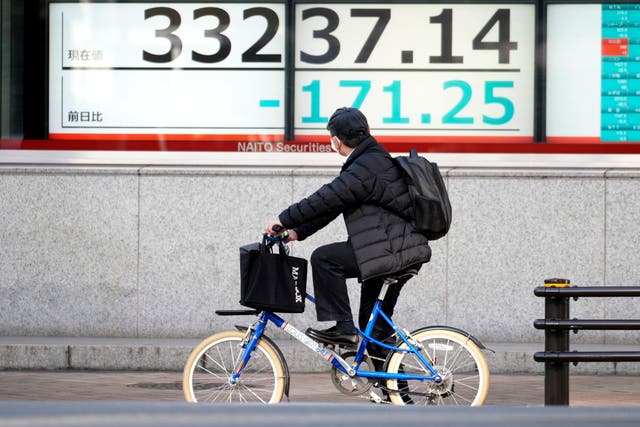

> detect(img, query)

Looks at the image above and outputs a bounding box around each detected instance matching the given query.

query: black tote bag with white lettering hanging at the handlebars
[240,237,307,313]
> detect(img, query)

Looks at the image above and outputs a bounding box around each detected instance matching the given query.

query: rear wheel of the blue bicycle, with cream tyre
[387,329,489,406]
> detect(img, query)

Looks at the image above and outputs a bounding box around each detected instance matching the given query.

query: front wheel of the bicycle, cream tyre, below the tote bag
[182,331,285,403]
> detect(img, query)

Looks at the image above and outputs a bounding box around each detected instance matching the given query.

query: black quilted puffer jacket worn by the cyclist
[279,137,431,280]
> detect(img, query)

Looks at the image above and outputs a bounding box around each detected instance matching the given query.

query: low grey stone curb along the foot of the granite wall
[0,337,640,375]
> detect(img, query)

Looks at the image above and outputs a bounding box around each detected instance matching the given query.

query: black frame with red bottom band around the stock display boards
[0,0,640,154]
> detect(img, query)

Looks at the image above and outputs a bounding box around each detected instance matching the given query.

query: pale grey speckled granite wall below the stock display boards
[0,165,640,350]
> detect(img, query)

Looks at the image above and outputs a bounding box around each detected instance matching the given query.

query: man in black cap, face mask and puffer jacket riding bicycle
[266,108,431,364]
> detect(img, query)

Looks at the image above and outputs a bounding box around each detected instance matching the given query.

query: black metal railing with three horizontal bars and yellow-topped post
[533,279,640,405]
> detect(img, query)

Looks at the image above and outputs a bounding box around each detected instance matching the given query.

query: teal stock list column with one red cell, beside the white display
[600,4,640,142]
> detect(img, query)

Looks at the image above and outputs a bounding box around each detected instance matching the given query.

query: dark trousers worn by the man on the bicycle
[311,242,402,366]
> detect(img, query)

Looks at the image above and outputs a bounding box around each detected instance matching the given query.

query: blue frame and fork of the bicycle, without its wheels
[231,292,442,383]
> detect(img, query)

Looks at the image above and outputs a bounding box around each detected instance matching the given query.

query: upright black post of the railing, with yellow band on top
[544,279,571,406]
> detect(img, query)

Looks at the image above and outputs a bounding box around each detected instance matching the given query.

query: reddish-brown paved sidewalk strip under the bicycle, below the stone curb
[0,370,640,407]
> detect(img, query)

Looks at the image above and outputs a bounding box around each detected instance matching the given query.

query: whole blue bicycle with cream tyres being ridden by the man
[183,234,489,406]
